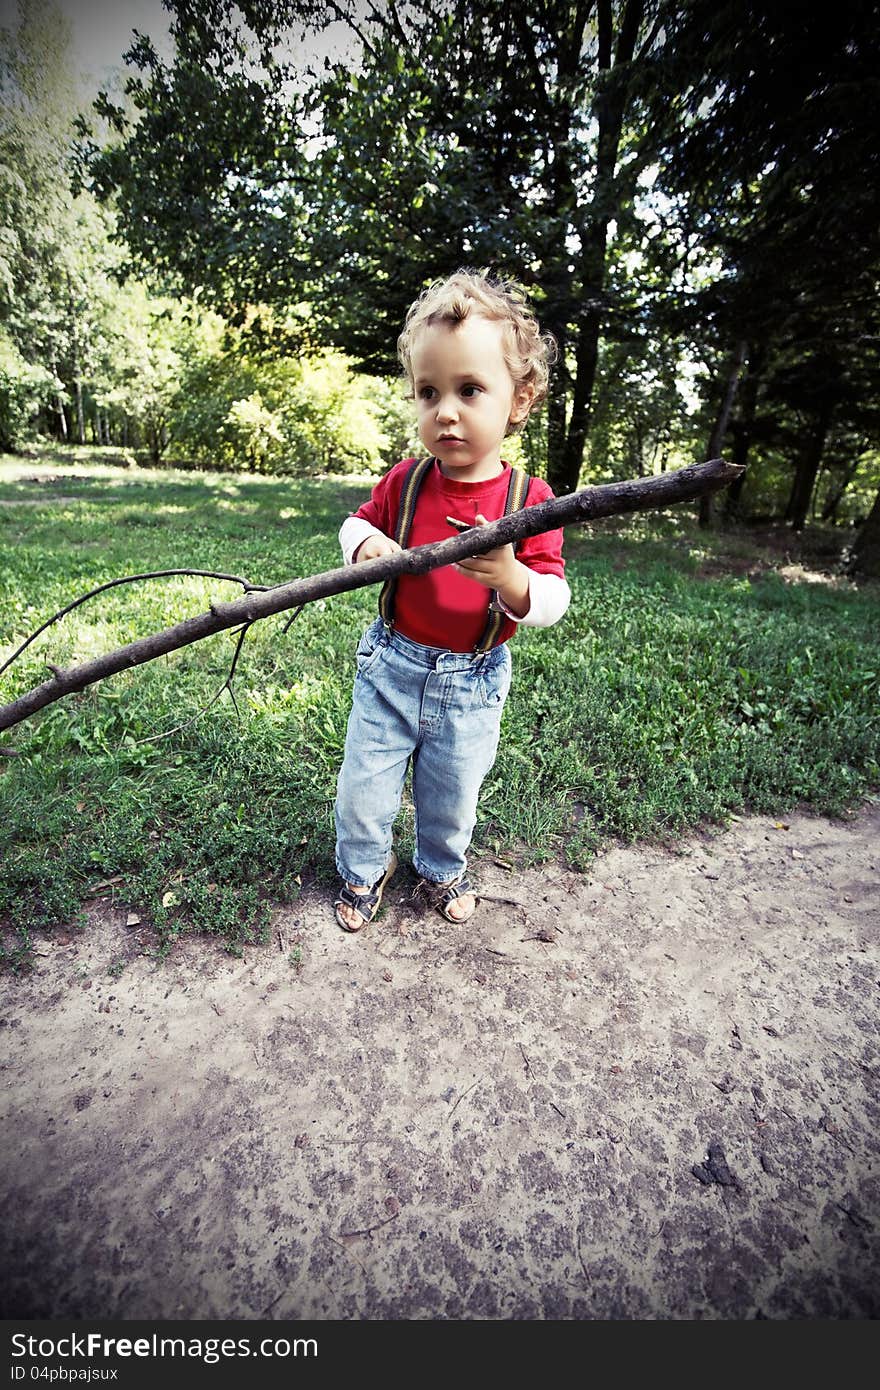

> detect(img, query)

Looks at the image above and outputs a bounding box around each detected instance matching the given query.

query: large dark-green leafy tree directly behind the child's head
[88,0,665,492]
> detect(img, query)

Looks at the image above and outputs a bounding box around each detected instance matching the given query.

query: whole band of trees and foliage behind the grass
[0,0,880,558]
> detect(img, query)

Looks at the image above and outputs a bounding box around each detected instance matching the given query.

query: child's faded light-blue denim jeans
[336,619,510,888]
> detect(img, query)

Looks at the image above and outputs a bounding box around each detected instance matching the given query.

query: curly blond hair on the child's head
[398,270,556,434]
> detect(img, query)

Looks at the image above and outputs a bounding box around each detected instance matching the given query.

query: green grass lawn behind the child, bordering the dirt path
[0,460,880,967]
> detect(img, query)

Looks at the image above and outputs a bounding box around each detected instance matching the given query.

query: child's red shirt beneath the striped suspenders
[355,459,564,652]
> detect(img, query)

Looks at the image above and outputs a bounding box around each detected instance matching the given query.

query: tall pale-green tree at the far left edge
[0,0,155,448]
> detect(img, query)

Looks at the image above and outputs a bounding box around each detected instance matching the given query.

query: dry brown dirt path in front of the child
[0,803,880,1319]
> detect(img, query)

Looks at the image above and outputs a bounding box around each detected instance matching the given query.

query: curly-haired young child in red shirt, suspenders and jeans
[335,271,570,931]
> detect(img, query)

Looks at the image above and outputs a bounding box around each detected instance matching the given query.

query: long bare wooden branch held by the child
[0,459,742,730]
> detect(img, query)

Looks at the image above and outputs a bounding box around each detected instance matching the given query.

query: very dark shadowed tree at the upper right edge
[645,0,880,528]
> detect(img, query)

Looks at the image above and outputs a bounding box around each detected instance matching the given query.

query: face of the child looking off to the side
[412,314,532,482]
